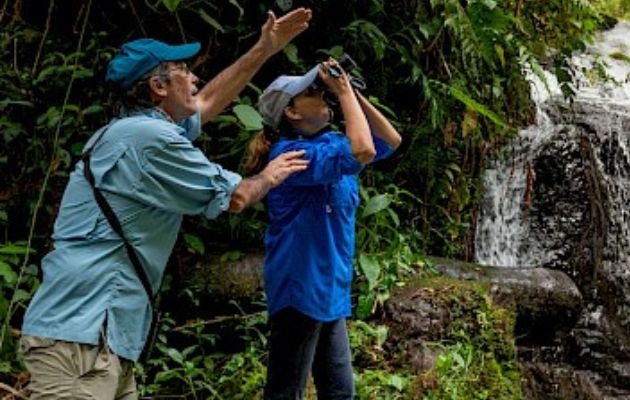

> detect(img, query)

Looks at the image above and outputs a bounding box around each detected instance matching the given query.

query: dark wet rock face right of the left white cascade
[529,102,630,396]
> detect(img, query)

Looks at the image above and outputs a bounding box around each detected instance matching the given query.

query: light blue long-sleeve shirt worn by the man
[22,109,241,361]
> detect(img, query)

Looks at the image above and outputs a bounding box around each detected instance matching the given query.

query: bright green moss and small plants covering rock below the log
[415,277,522,400]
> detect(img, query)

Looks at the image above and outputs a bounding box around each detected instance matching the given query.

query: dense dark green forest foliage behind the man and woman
[0,0,616,399]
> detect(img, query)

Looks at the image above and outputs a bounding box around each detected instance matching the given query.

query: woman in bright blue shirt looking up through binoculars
[246,59,401,400]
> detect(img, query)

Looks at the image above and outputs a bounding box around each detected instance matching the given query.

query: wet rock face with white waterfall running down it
[476,22,630,398]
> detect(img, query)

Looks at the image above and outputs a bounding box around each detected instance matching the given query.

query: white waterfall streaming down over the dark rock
[475,22,630,267]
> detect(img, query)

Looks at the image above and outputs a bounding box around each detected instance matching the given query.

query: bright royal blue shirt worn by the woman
[264,131,393,322]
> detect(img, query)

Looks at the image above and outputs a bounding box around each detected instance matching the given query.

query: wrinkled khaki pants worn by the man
[20,336,138,400]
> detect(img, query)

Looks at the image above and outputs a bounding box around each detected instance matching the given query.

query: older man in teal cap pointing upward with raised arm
[21,8,311,400]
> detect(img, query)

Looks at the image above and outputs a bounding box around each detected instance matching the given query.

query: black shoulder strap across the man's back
[82,126,155,306]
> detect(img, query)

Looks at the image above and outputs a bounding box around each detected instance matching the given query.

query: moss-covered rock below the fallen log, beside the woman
[386,276,522,400]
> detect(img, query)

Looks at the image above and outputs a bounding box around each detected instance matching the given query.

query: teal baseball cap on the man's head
[105,39,201,90]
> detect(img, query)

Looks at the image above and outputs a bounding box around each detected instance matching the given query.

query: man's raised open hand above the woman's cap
[258,7,312,57]
